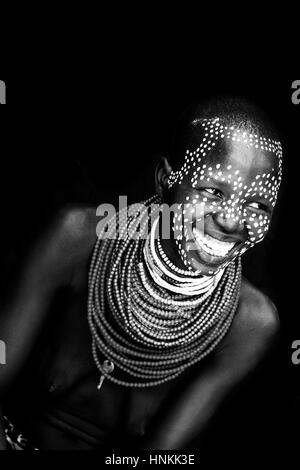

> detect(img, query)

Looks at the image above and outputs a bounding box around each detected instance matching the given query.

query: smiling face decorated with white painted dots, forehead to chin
[168,118,282,275]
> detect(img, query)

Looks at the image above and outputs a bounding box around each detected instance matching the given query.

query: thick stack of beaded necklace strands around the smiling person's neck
[88,196,241,388]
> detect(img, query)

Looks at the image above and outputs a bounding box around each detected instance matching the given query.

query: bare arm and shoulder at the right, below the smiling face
[141,288,279,449]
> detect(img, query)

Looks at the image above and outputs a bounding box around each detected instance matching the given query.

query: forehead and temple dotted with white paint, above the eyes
[168,118,282,187]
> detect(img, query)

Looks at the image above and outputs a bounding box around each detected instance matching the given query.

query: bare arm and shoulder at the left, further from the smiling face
[0,209,94,448]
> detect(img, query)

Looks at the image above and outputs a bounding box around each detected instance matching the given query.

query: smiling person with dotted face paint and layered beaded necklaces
[0,94,282,450]
